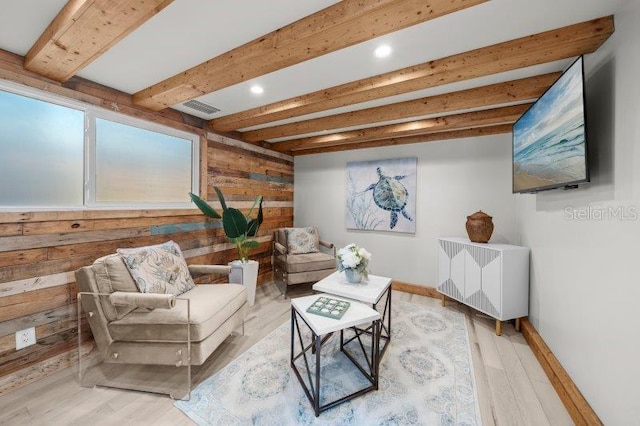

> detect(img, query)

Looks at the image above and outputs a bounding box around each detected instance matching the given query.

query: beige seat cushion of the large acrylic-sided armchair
[109,284,247,342]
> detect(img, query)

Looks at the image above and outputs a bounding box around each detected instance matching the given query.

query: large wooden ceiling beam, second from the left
[133,0,487,111]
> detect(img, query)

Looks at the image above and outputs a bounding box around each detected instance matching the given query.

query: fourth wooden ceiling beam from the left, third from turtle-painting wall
[241,72,560,142]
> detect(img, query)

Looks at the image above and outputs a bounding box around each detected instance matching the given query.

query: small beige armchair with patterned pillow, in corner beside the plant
[272,227,336,298]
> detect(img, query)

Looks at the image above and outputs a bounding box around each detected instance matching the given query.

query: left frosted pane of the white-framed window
[0,91,84,207]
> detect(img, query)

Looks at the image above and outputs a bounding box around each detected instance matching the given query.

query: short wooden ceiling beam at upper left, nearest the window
[24,0,173,82]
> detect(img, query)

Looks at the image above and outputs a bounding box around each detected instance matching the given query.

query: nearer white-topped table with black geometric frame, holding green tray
[290,294,380,417]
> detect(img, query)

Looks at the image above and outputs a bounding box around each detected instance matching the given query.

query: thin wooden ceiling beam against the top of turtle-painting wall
[291,124,513,156]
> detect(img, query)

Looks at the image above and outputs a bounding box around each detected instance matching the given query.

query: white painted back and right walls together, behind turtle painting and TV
[294,0,640,425]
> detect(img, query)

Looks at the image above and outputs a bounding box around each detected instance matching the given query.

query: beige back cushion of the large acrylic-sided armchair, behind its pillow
[92,253,139,321]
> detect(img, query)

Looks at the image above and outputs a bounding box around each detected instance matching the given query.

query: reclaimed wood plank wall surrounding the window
[0,50,293,396]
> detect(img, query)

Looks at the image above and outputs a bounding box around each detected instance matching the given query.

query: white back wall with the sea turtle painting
[294,135,516,286]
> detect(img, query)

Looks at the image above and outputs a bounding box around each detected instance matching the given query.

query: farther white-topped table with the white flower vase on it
[313,271,391,358]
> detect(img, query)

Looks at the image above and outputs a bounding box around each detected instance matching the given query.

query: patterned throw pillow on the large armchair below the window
[117,241,195,296]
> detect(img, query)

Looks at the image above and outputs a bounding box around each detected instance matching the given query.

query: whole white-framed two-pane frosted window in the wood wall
[0,82,199,209]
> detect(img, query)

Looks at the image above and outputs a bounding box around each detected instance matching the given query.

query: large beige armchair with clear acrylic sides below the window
[75,243,249,398]
